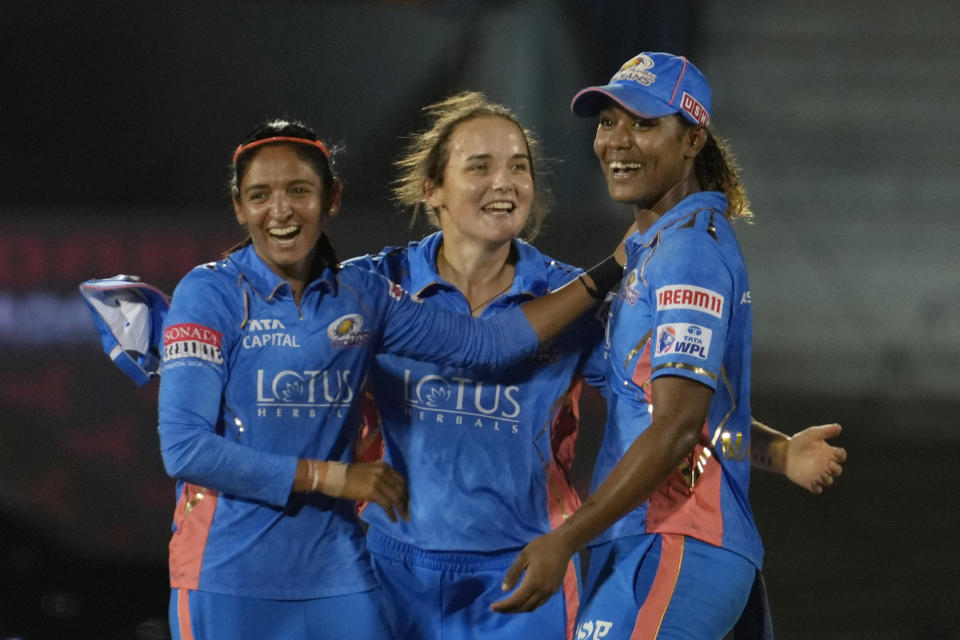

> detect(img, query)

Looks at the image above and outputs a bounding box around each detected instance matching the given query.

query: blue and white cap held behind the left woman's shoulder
[80,275,170,386]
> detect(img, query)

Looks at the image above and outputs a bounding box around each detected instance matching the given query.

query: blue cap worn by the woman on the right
[570,53,713,126]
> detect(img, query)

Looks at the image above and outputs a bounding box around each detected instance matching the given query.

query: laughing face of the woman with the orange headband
[233,144,340,281]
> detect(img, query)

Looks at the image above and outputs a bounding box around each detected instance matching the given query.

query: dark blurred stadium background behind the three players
[0,0,960,640]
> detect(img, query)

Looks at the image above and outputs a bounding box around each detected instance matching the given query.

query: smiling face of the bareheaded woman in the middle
[424,116,534,245]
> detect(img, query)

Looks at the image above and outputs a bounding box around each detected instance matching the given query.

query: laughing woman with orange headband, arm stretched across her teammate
[159,121,619,640]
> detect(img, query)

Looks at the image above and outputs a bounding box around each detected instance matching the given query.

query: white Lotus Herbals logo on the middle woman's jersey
[403,369,520,434]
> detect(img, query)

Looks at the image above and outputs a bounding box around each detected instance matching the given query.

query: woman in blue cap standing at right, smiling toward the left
[494,53,845,640]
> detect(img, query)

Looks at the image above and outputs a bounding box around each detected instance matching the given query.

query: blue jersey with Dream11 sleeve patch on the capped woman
[590,191,763,567]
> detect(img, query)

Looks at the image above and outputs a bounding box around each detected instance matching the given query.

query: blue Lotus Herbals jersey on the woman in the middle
[351,232,602,552]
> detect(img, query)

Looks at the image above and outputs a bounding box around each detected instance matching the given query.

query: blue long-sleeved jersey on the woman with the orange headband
[159,237,537,599]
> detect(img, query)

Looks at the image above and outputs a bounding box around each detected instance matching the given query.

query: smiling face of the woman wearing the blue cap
[593,104,706,214]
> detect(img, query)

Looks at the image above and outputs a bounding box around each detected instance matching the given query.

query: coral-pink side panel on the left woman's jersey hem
[170,484,220,589]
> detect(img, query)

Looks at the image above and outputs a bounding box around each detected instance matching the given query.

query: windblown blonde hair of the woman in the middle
[393,91,552,240]
